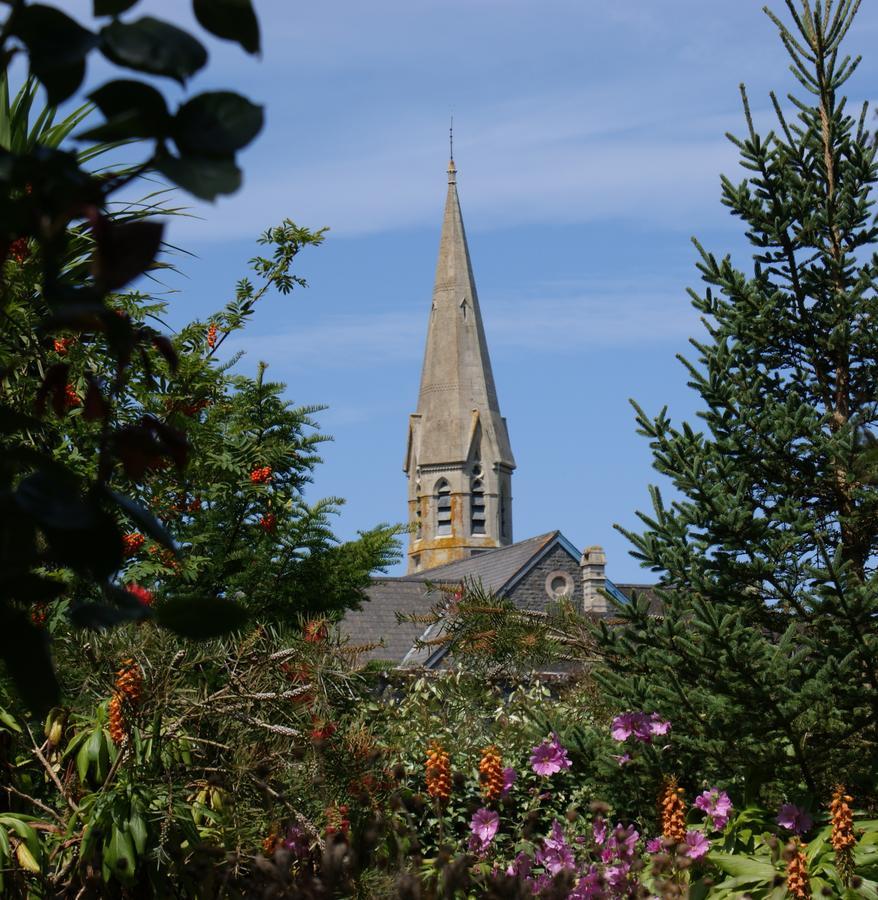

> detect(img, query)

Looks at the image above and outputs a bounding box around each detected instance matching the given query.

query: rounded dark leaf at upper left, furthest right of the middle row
[171,91,263,157]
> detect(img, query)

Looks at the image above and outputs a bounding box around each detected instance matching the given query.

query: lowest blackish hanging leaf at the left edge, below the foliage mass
[0,606,60,715]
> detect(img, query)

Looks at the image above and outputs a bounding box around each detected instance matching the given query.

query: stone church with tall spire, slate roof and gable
[341,158,651,668]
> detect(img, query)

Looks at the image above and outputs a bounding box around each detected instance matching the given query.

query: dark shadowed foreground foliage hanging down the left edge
[0,0,262,710]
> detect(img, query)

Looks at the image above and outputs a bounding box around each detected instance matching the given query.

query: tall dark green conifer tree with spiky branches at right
[599,0,878,791]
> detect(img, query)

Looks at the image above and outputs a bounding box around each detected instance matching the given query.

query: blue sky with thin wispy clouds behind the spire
[62,0,878,581]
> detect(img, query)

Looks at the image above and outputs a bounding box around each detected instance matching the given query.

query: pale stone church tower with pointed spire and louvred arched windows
[403,157,515,574]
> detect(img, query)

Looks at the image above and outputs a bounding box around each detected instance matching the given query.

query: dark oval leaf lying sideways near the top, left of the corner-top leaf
[100,16,207,84]
